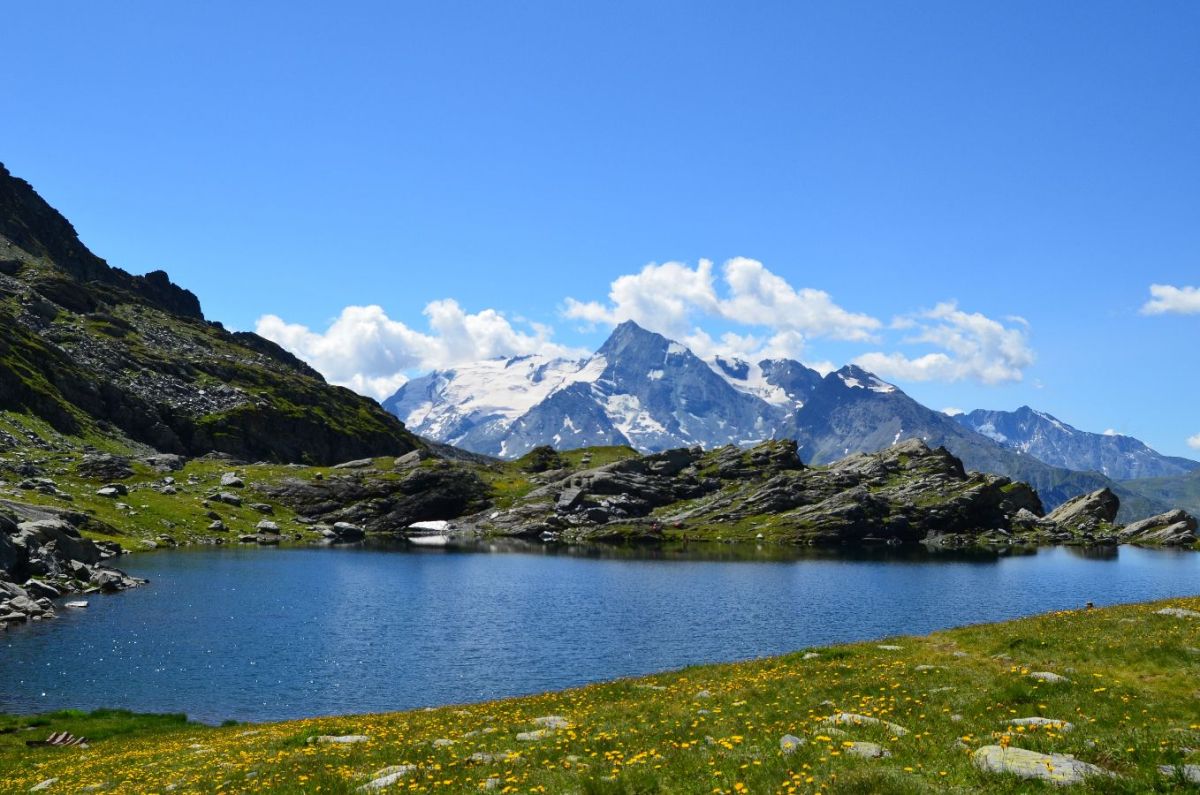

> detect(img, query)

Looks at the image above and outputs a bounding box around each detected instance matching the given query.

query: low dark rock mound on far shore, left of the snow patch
[259,466,488,533]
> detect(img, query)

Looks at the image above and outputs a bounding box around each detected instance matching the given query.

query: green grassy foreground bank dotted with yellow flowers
[0,598,1200,794]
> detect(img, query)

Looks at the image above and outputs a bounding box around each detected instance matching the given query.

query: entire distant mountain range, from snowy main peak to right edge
[384,322,1200,519]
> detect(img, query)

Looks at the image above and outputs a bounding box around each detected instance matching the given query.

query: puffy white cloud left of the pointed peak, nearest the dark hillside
[256,300,583,399]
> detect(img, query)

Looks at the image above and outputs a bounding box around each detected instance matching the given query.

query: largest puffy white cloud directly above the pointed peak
[563,257,882,358]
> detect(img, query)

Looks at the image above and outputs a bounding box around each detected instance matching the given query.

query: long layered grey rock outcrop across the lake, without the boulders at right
[467,440,1043,544]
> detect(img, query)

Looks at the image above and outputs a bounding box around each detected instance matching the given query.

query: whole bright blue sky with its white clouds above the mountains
[0,0,1200,455]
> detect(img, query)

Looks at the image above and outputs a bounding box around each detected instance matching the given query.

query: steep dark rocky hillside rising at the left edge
[0,166,420,464]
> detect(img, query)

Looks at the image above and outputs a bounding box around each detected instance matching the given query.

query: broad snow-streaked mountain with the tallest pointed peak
[384,322,821,458]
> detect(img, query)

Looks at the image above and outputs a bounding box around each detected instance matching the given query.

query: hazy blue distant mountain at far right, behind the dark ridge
[955,406,1200,480]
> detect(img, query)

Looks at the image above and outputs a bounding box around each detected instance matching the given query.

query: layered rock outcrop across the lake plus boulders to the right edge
[452,440,1196,548]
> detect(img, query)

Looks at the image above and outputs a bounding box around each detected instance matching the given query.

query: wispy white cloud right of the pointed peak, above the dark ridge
[854,301,1034,384]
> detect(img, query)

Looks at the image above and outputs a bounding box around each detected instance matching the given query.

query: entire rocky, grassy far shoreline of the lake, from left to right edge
[0,440,1198,626]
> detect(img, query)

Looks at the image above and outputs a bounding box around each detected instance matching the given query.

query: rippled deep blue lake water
[0,546,1200,722]
